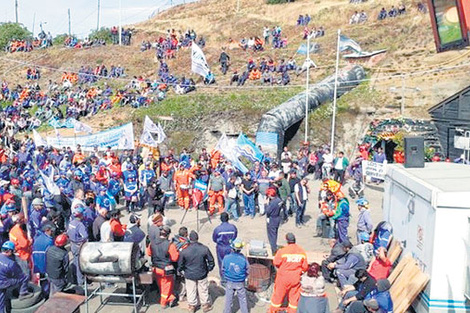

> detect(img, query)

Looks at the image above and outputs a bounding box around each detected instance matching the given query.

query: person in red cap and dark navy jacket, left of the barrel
[46,234,69,297]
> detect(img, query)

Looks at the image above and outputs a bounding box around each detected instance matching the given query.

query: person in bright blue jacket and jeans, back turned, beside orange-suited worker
[222,238,250,313]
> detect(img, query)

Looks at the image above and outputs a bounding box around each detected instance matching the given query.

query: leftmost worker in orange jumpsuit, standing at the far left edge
[9,213,33,277]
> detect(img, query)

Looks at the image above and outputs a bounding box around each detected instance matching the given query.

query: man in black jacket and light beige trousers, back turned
[178,230,215,313]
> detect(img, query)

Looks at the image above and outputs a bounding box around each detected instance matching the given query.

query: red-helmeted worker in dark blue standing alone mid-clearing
[266,187,284,255]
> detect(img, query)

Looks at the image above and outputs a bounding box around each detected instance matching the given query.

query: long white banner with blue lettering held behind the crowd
[47,123,134,151]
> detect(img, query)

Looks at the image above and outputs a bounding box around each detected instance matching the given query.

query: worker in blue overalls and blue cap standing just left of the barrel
[67,206,88,287]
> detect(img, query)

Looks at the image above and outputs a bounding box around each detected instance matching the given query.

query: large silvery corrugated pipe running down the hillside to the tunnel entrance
[258,65,366,157]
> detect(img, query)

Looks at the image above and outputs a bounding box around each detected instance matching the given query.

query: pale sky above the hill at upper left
[0,0,195,38]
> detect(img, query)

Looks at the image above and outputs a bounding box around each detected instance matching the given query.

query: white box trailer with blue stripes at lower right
[383,162,470,313]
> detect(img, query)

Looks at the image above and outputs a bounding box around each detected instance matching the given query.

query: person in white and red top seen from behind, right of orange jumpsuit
[297,263,330,313]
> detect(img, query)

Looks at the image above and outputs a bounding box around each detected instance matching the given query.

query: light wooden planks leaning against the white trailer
[388,255,429,313]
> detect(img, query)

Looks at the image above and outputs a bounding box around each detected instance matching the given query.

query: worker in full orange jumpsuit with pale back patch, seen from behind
[269,233,308,313]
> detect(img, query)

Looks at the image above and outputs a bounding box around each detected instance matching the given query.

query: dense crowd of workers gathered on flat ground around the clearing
[0,136,392,313]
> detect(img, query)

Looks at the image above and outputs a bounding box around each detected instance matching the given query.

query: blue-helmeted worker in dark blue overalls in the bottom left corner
[0,241,33,313]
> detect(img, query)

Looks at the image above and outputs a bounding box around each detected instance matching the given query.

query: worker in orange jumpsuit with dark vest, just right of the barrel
[147,226,179,309]
